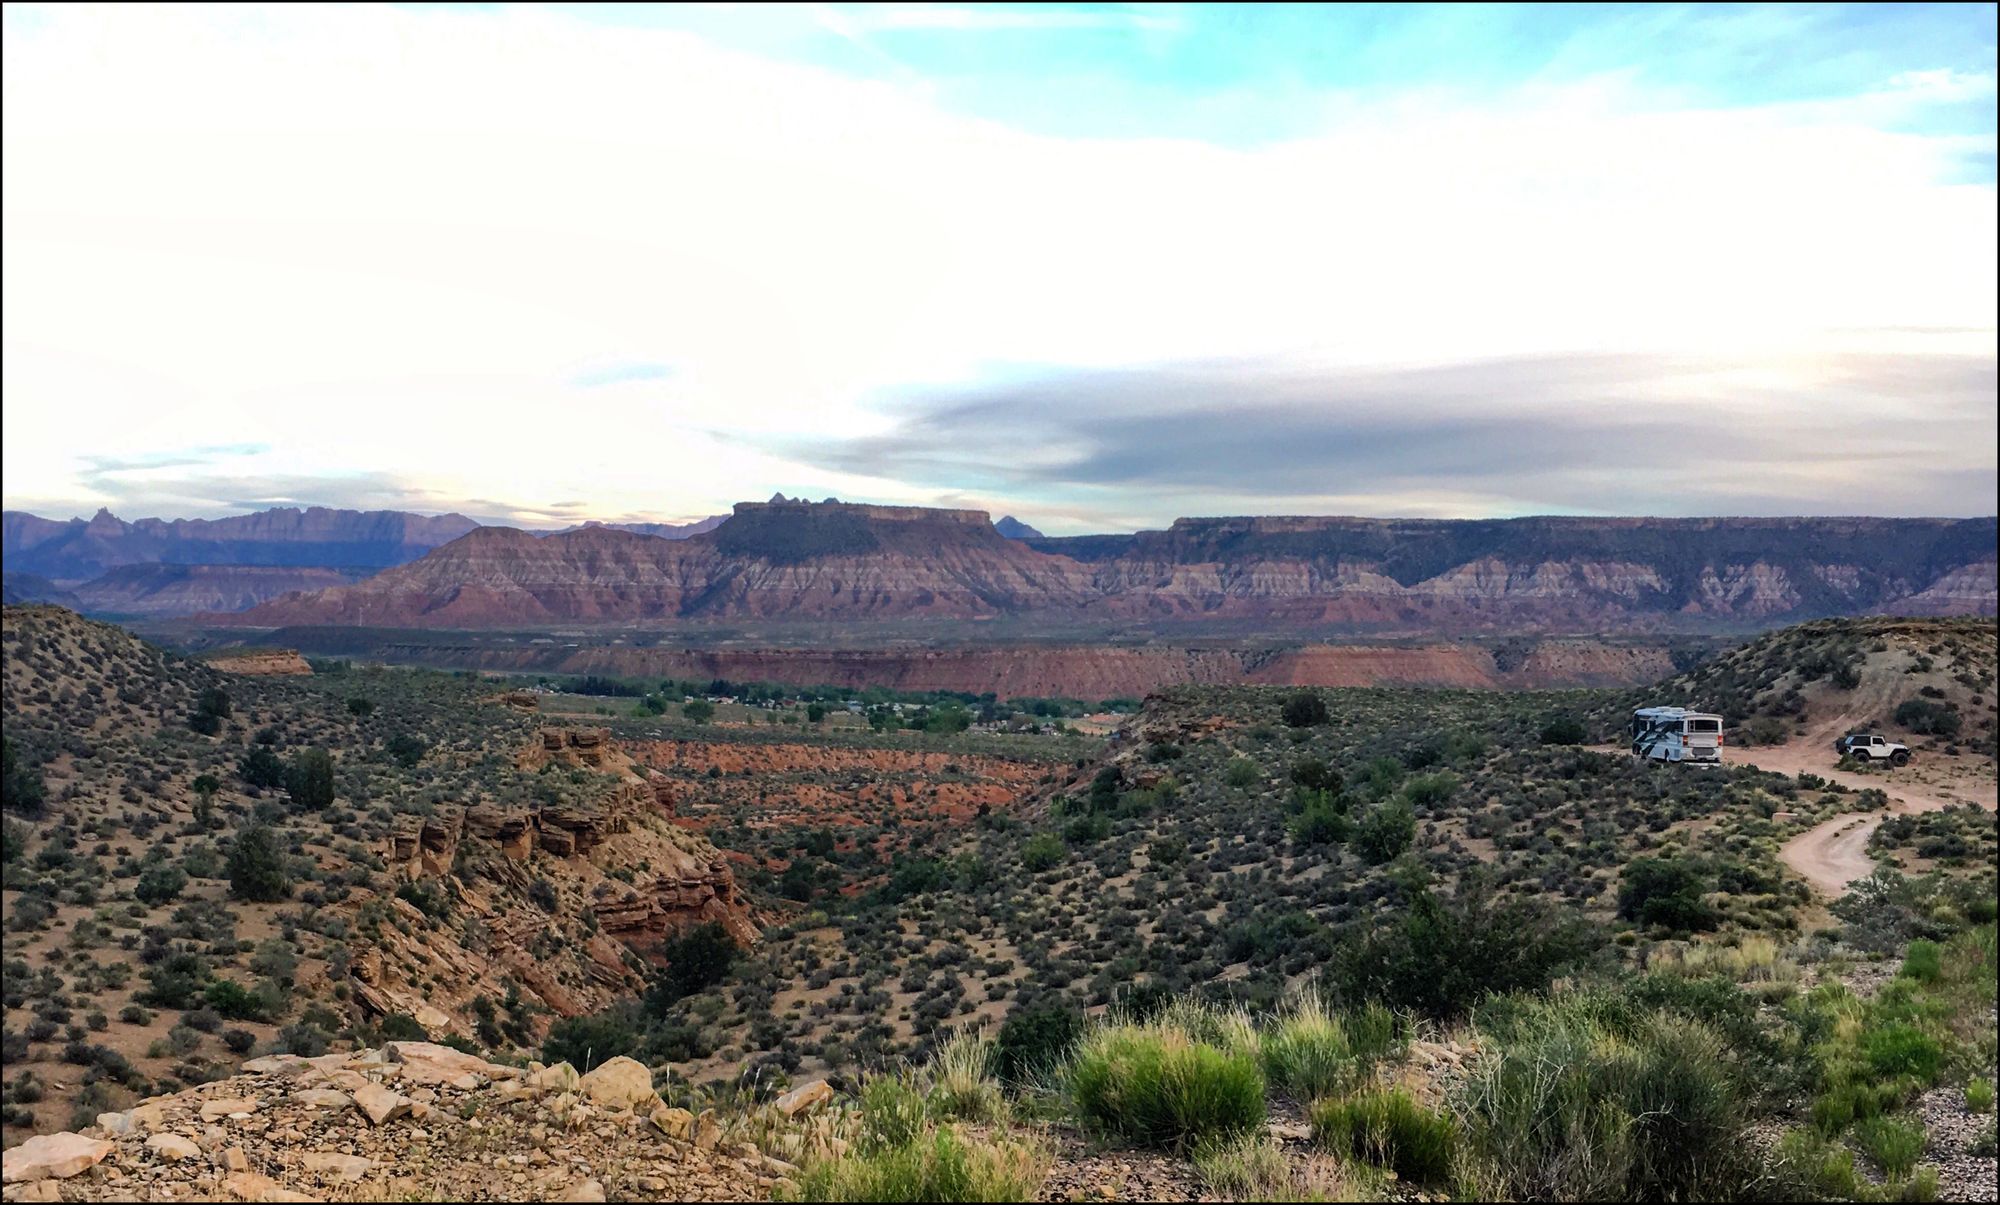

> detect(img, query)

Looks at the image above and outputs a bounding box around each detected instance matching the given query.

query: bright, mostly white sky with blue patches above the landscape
[0,4,2000,534]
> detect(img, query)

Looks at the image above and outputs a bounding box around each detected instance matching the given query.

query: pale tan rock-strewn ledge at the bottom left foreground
[0,1043,840,1201]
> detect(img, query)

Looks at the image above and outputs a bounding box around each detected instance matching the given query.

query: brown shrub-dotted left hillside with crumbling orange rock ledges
[0,607,756,1133]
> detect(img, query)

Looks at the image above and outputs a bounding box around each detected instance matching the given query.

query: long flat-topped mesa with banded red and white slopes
[228,502,1996,635]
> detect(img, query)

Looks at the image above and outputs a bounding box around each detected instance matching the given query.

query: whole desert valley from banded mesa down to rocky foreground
[4,492,2000,1199]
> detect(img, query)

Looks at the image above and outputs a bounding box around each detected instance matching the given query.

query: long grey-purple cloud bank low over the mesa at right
[780,346,2000,522]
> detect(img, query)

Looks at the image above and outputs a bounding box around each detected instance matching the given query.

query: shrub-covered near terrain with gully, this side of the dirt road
[4,607,1994,1201]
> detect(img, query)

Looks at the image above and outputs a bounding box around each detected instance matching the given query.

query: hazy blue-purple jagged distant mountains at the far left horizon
[0,506,478,588]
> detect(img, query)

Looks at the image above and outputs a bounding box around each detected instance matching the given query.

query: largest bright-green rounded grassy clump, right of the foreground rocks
[1068,1025,1264,1149]
